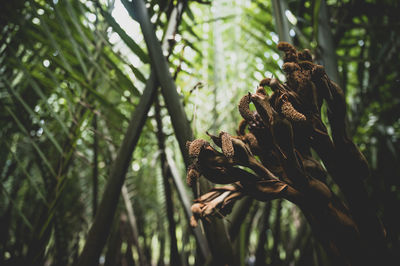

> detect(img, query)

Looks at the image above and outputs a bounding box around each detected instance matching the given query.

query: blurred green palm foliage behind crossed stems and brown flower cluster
[0,0,400,265]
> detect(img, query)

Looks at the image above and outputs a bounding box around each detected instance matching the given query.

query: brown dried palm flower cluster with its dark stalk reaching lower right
[187,42,385,265]
